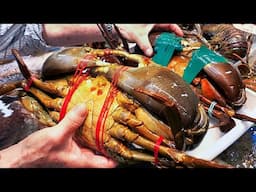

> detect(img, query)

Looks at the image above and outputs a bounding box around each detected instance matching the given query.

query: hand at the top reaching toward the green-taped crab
[116,24,183,57]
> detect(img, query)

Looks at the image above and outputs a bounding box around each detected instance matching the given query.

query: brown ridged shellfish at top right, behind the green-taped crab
[182,24,250,62]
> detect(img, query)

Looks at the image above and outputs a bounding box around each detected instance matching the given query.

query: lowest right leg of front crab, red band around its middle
[109,125,231,168]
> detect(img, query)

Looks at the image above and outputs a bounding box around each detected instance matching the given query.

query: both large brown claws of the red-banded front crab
[42,47,208,149]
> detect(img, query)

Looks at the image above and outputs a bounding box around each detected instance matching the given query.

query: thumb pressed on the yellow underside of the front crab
[57,103,88,138]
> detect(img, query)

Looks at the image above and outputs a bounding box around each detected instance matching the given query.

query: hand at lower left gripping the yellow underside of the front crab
[0,104,116,168]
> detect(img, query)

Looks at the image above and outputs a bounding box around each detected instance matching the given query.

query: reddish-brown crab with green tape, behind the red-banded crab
[146,30,256,132]
